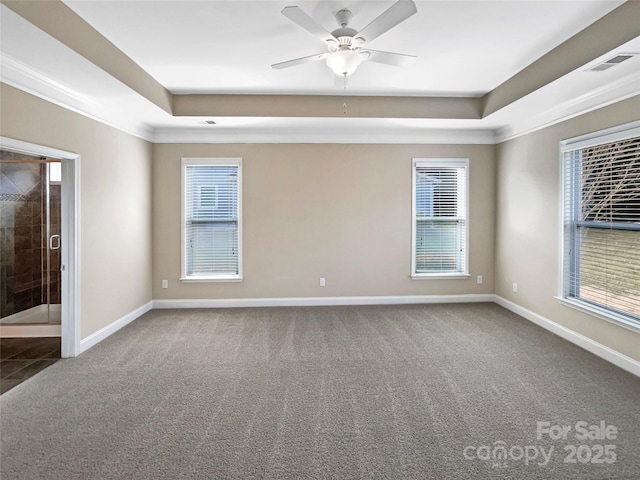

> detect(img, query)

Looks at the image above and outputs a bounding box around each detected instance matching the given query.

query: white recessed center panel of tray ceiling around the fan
[65,0,622,96]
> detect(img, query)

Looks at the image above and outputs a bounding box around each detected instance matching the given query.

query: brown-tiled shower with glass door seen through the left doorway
[0,154,63,325]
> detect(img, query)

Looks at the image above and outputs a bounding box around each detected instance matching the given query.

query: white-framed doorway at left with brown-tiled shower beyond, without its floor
[0,137,79,357]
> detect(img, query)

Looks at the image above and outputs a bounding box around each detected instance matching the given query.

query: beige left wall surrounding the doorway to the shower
[0,85,152,338]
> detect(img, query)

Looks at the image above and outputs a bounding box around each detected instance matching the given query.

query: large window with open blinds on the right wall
[561,124,640,326]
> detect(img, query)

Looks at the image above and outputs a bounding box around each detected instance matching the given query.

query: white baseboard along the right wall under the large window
[495,295,640,377]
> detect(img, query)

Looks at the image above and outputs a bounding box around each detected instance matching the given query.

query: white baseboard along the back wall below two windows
[153,294,494,309]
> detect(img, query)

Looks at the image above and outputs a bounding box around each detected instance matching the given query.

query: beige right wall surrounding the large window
[495,97,640,360]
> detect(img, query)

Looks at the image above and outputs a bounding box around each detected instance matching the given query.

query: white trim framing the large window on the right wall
[556,121,640,332]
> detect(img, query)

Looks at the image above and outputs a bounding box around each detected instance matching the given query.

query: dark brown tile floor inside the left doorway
[0,337,60,394]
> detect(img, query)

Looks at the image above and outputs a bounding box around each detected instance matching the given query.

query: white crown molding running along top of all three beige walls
[0,54,640,145]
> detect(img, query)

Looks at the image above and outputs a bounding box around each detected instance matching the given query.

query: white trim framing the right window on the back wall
[410,158,470,280]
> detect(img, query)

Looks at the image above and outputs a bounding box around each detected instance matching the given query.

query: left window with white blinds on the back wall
[181,158,242,282]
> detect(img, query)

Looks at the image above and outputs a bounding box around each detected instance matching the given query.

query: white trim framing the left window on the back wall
[180,157,243,283]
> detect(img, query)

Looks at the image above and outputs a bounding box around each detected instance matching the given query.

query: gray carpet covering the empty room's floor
[0,304,640,480]
